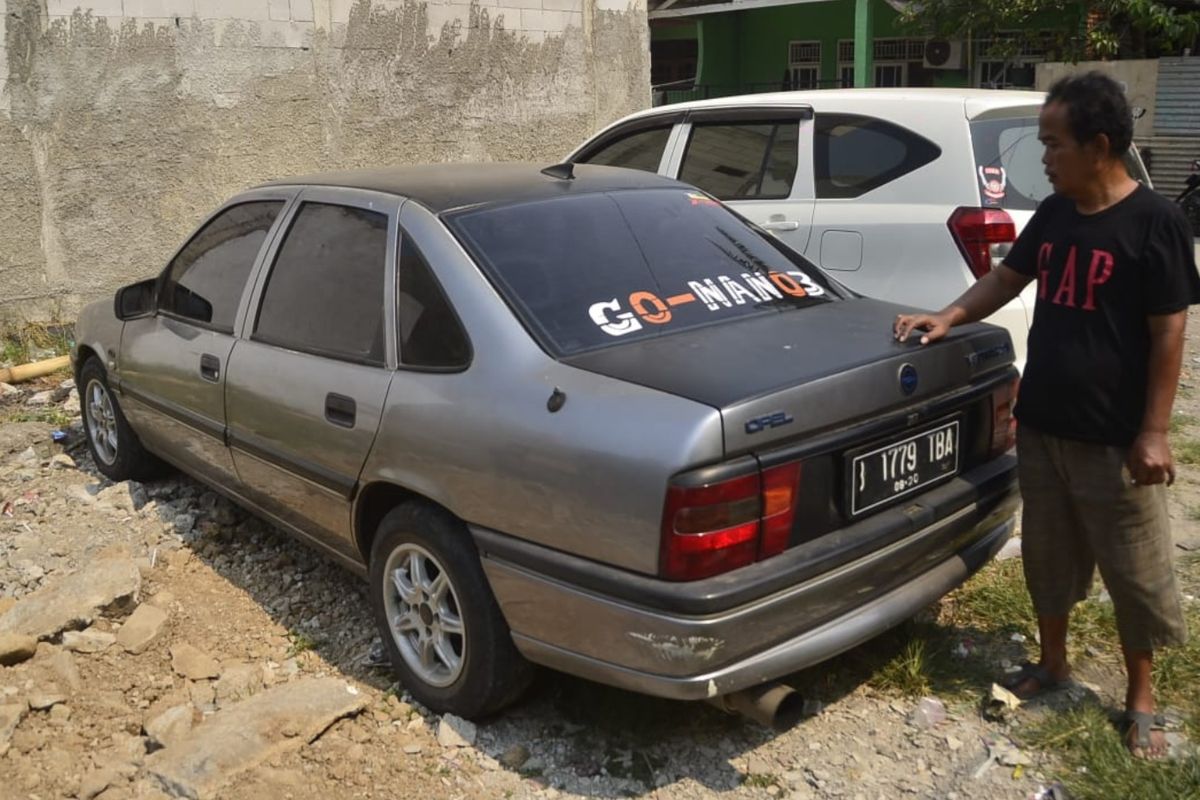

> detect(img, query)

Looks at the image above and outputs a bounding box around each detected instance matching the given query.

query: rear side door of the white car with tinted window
[666,108,814,253]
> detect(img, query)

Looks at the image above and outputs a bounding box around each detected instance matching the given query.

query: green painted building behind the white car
[649,0,1075,103]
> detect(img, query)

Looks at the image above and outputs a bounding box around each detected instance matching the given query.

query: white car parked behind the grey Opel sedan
[569,89,1150,367]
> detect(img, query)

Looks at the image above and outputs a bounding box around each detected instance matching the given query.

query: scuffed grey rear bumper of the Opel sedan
[475,457,1018,699]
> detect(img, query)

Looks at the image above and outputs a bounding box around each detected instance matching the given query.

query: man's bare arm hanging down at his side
[1128,311,1188,486]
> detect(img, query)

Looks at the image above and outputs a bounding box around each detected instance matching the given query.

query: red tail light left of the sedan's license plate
[659,462,800,581]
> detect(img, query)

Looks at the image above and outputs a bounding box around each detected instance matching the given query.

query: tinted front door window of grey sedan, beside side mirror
[158,206,283,333]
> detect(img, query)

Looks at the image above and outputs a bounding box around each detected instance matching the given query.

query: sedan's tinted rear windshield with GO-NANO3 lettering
[448,188,835,356]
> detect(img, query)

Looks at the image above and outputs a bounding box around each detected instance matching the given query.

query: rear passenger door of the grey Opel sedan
[226,188,401,559]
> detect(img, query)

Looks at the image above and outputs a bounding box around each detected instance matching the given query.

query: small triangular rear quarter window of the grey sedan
[396,241,470,369]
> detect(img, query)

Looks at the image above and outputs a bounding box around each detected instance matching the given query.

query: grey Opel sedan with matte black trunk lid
[73,164,1016,716]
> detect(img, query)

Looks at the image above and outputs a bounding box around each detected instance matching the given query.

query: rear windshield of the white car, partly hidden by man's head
[971,115,1147,211]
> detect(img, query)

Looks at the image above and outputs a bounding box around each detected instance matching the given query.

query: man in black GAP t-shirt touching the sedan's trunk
[895,72,1200,758]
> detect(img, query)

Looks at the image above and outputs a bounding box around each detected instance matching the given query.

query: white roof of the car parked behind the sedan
[634,88,1045,118]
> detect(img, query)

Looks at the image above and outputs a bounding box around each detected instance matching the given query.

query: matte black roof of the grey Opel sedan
[255,163,685,213]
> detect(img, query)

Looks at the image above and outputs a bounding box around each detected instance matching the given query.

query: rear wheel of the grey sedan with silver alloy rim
[370,503,533,718]
